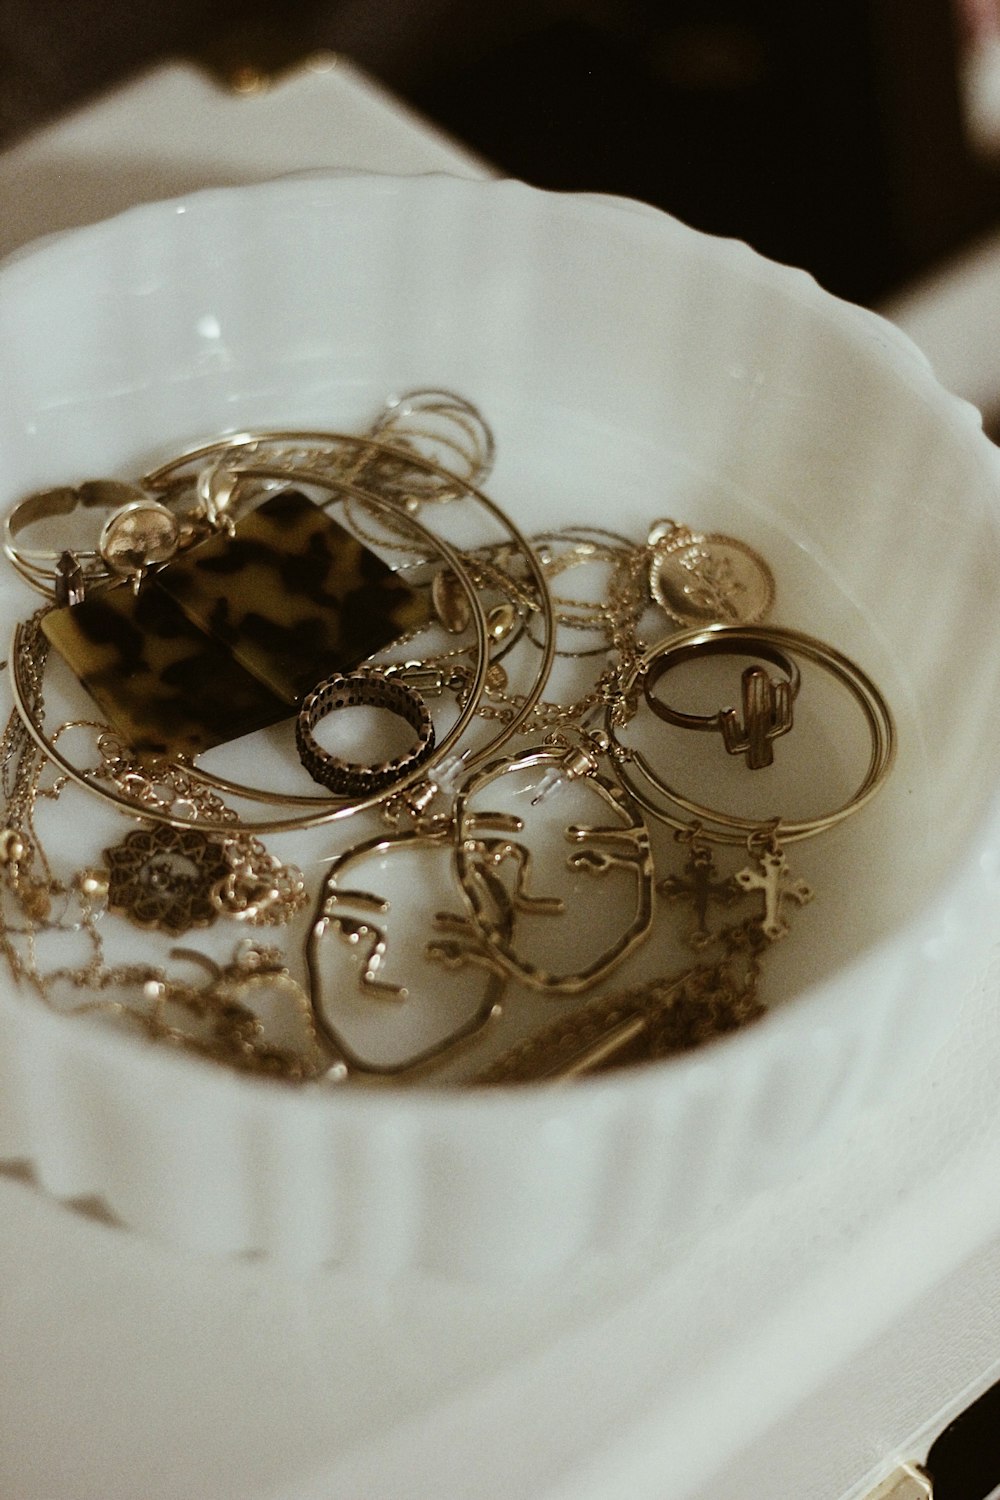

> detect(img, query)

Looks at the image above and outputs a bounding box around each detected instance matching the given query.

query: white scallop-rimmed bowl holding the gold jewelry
[0,176,1000,1277]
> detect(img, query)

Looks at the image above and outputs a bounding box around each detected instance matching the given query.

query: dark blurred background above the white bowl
[0,0,1000,303]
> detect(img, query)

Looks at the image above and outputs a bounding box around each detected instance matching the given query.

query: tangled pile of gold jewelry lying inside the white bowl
[0,390,895,1085]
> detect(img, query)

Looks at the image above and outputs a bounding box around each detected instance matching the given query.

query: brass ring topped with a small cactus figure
[642,627,799,771]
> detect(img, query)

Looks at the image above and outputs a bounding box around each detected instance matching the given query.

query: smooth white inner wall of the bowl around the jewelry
[0,177,1000,1068]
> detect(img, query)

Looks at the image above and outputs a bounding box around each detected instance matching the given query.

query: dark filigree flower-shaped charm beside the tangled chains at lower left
[105,824,229,936]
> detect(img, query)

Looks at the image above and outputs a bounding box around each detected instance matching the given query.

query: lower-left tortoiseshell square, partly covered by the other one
[42,582,291,761]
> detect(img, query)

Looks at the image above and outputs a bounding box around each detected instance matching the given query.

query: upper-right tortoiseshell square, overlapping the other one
[152,489,430,707]
